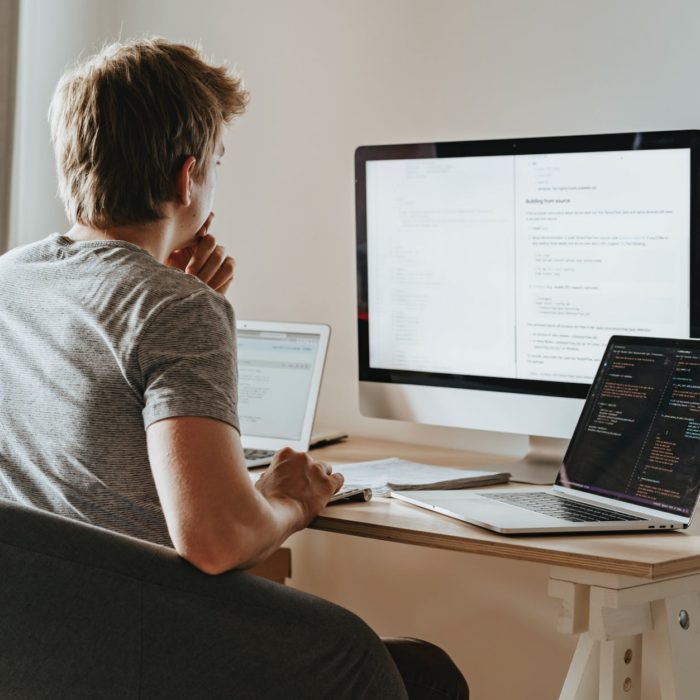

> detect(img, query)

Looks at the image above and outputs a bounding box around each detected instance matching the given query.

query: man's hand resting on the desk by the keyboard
[256,447,344,529]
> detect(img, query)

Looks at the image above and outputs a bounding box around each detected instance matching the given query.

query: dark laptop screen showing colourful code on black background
[556,336,700,516]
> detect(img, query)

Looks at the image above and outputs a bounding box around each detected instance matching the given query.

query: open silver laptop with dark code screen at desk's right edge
[391,336,700,534]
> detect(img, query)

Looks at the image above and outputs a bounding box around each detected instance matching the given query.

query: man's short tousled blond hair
[49,38,248,229]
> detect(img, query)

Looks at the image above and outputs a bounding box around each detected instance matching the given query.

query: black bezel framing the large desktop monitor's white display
[355,130,700,399]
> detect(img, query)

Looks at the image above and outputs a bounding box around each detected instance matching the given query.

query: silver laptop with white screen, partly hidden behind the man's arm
[236,321,330,468]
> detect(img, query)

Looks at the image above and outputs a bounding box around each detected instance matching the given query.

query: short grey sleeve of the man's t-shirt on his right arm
[136,290,240,432]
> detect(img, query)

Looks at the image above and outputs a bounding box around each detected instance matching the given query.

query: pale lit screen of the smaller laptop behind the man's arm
[237,328,321,440]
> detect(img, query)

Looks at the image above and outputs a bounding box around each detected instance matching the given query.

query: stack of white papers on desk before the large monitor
[333,457,510,496]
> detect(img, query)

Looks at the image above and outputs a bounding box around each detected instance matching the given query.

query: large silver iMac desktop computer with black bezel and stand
[355,131,700,483]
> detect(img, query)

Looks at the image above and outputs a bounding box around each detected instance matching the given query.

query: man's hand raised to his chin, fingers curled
[166,212,236,294]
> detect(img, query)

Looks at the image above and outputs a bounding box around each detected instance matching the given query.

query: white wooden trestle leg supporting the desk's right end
[549,567,700,700]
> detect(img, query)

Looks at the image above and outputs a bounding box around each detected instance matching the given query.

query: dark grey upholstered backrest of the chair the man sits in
[0,500,403,700]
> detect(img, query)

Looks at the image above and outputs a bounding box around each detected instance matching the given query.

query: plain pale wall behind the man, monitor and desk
[14,0,700,700]
